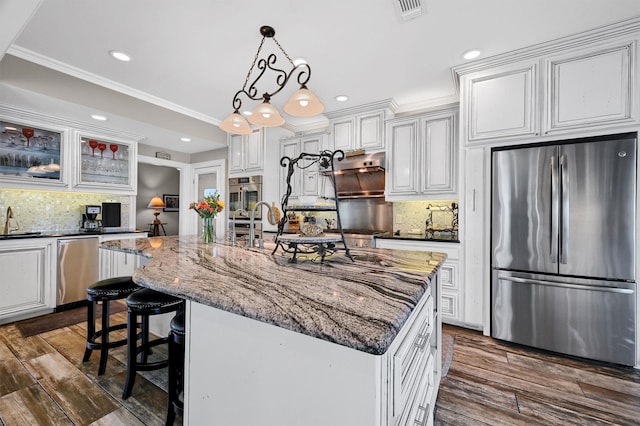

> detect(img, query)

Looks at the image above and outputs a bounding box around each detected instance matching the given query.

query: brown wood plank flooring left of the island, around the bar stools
[0,302,182,426]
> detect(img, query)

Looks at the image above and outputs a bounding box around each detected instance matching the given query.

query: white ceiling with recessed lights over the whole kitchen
[0,0,640,153]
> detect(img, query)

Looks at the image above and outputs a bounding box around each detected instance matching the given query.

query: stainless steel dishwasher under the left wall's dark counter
[56,237,100,310]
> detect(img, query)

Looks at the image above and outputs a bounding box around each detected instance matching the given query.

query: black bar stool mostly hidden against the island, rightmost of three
[166,311,185,426]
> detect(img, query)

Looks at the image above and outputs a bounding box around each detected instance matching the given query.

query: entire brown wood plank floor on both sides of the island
[0,313,640,426]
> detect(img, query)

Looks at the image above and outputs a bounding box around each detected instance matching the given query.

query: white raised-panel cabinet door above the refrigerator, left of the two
[461,61,539,144]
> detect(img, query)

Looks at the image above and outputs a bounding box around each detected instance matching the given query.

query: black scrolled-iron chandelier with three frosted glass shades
[220,25,324,135]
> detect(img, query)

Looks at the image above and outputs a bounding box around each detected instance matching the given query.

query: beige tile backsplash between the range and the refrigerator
[393,200,458,233]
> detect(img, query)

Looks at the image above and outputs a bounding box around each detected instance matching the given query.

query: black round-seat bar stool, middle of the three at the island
[122,288,184,399]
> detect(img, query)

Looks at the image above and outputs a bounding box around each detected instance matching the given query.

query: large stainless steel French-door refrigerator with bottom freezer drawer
[491,134,636,365]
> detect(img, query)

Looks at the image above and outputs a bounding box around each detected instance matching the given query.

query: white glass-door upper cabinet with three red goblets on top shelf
[74,132,137,193]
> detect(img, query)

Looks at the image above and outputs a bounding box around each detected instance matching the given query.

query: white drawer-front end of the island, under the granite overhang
[391,296,433,424]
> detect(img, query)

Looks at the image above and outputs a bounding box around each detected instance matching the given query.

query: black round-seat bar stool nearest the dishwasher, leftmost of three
[82,277,140,376]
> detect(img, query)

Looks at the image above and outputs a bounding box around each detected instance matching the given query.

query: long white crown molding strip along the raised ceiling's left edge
[7,44,220,126]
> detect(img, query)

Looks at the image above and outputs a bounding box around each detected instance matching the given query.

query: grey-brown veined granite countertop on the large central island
[102,236,446,355]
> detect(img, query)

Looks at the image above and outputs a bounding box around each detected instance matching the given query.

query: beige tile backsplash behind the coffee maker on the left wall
[0,189,130,232]
